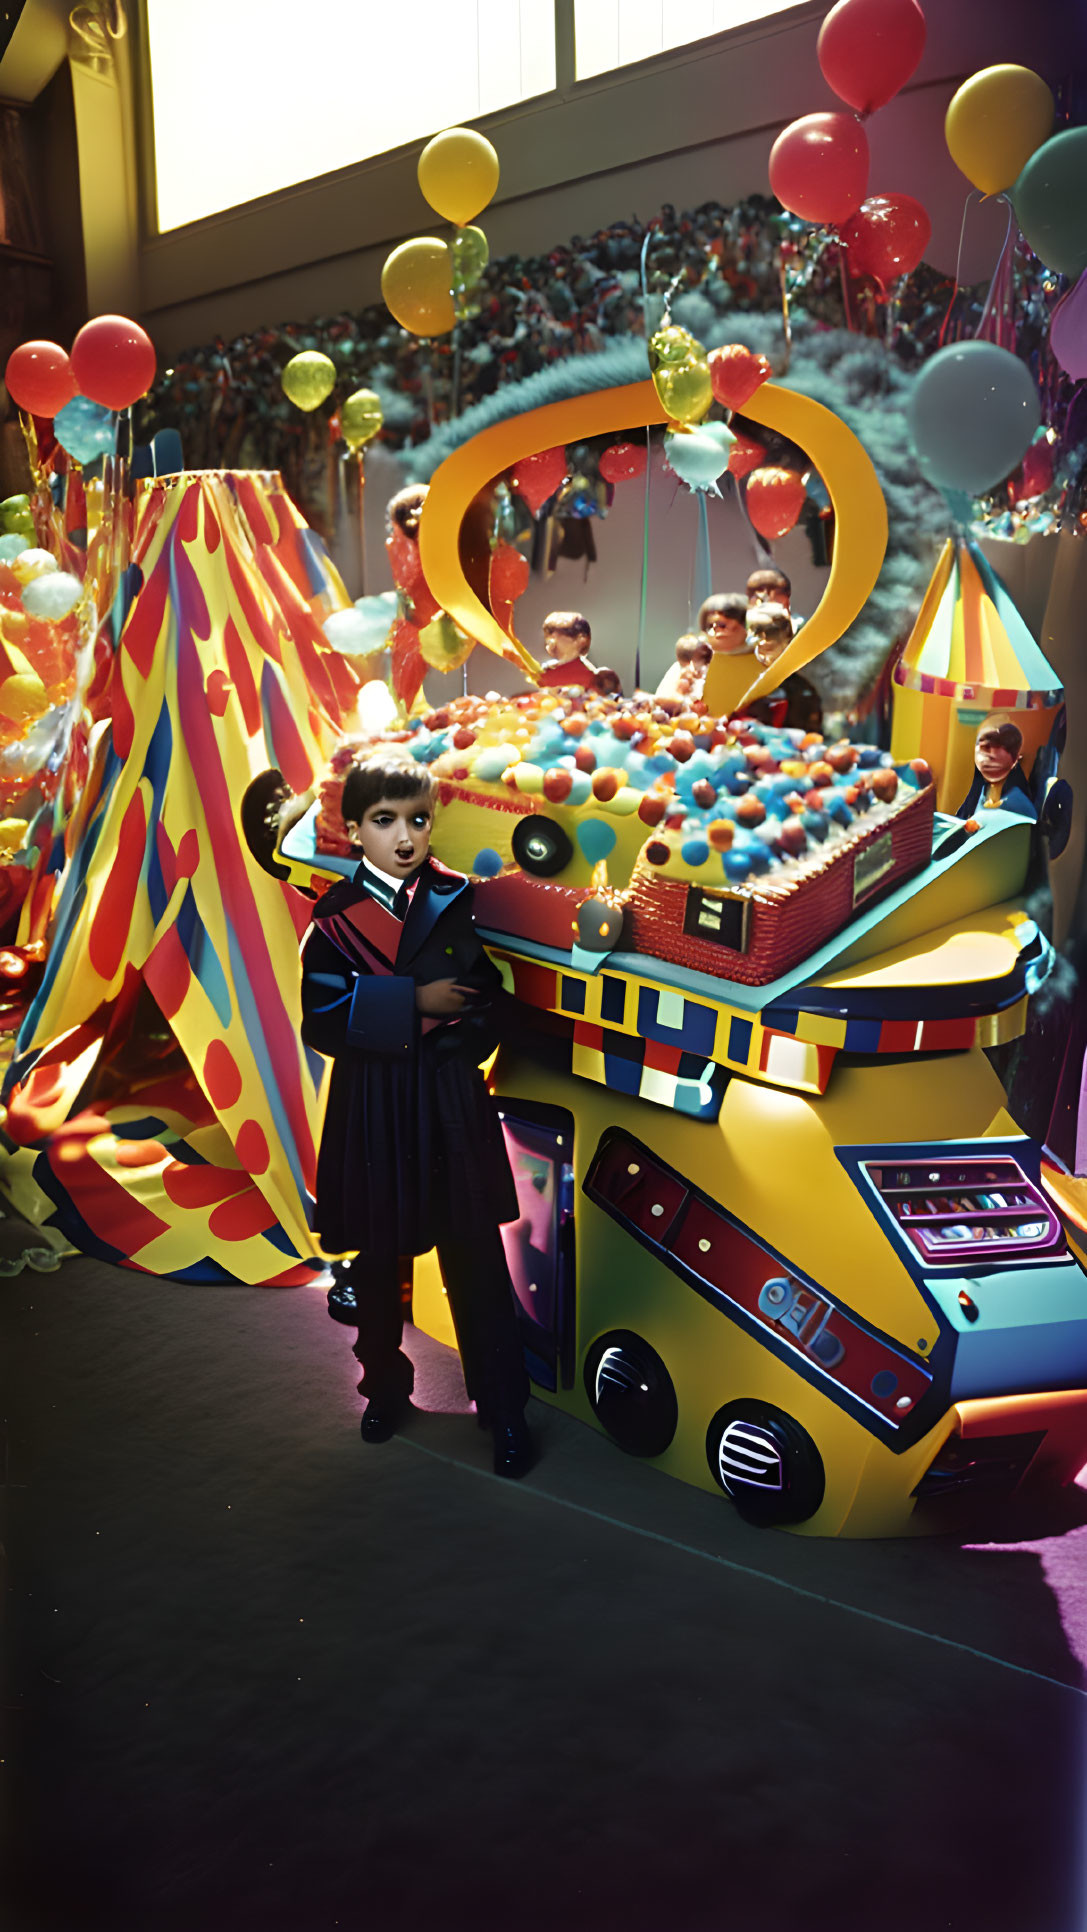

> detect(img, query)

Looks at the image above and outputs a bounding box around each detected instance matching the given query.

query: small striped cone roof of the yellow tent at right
[894,537,1064,711]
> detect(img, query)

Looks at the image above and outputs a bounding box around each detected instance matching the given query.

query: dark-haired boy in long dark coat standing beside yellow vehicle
[301,759,531,1476]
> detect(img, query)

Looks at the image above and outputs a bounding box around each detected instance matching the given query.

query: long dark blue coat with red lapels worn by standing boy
[301,860,519,1258]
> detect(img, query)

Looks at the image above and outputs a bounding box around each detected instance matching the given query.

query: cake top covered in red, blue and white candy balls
[319,692,931,889]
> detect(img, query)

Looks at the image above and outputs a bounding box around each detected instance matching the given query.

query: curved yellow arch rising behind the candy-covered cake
[419,370,886,715]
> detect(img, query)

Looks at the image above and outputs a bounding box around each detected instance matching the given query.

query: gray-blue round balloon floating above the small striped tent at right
[906,342,1041,497]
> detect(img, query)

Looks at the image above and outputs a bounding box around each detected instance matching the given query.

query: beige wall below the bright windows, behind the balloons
[125,0,1075,352]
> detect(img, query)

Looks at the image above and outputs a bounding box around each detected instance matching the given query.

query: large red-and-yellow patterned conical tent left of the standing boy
[6,473,357,1283]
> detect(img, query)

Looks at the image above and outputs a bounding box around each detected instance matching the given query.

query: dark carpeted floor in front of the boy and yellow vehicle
[0,1260,1087,1932]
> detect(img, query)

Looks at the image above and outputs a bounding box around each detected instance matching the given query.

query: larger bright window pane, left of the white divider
[147,0,554,230]
